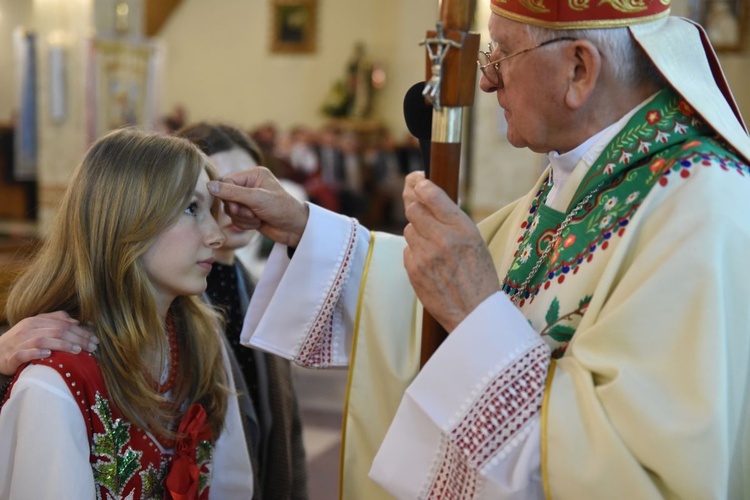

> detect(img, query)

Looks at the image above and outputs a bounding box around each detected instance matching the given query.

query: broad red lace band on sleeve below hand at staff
[427,344,549,500]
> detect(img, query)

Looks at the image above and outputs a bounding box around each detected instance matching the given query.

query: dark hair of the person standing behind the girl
[175,122,265,165]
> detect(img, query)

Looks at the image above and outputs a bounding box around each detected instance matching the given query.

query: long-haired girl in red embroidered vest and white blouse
[0,129,252,499]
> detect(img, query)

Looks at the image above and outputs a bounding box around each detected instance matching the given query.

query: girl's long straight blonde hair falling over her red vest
[7,129,227,439]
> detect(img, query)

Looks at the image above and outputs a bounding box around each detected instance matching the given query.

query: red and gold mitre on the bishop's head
[490,0,671,30]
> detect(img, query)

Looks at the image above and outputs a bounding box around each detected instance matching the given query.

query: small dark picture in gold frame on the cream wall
[271,0,318,54]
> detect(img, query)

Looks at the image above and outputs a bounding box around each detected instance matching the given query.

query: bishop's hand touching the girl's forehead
[208,167,309,247]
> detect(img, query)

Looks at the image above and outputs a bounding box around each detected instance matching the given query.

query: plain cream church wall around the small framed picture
[159,0,437,136]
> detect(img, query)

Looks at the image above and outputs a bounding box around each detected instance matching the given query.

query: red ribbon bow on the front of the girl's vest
[166,403,211,500]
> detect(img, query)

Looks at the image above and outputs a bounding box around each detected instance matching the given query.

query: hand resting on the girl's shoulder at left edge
[0,311,99,375]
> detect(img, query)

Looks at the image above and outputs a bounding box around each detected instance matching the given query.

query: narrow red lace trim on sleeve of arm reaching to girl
[296,220,357,368]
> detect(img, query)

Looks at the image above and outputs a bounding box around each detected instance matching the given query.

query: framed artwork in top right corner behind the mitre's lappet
[691,0,747,52]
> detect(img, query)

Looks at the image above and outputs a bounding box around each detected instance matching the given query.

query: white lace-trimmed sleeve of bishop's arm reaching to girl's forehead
[241,204,370,368]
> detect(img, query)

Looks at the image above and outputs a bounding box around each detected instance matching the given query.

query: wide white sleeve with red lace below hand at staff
[370,292,550,499]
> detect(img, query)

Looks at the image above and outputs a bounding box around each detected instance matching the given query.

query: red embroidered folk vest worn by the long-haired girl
[6,352,213,500]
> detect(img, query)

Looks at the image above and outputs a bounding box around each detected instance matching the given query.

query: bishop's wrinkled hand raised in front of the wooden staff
[404,172,500,332]
